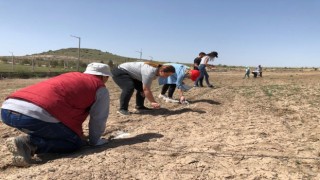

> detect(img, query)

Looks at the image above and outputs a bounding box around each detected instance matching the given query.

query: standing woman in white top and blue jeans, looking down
[194,51,218,87]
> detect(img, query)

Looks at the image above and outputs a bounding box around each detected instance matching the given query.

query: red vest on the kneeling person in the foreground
[8,72,105,136]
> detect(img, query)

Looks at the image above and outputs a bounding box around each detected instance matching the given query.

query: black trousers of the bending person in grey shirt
[112,67,145,110]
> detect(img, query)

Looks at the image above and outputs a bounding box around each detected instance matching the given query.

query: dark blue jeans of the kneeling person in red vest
[1,109,84,154]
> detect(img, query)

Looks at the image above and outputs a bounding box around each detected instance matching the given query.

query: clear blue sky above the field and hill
[0,0,320,67]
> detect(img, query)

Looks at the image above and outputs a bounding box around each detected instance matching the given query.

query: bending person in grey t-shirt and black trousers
[112,62,175,115]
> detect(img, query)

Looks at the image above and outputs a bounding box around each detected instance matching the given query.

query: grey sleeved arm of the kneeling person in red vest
[89,87,110,145]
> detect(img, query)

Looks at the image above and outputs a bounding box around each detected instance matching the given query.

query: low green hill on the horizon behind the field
[0,48,145,72]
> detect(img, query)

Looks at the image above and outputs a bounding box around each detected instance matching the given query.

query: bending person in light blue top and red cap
[158,63,200,103]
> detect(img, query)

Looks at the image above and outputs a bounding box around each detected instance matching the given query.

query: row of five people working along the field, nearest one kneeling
[1,52,218,166]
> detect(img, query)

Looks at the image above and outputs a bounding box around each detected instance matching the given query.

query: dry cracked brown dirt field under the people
[0,71,320,180]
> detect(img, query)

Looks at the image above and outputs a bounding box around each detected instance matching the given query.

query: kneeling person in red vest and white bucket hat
[1,63,112,166]
